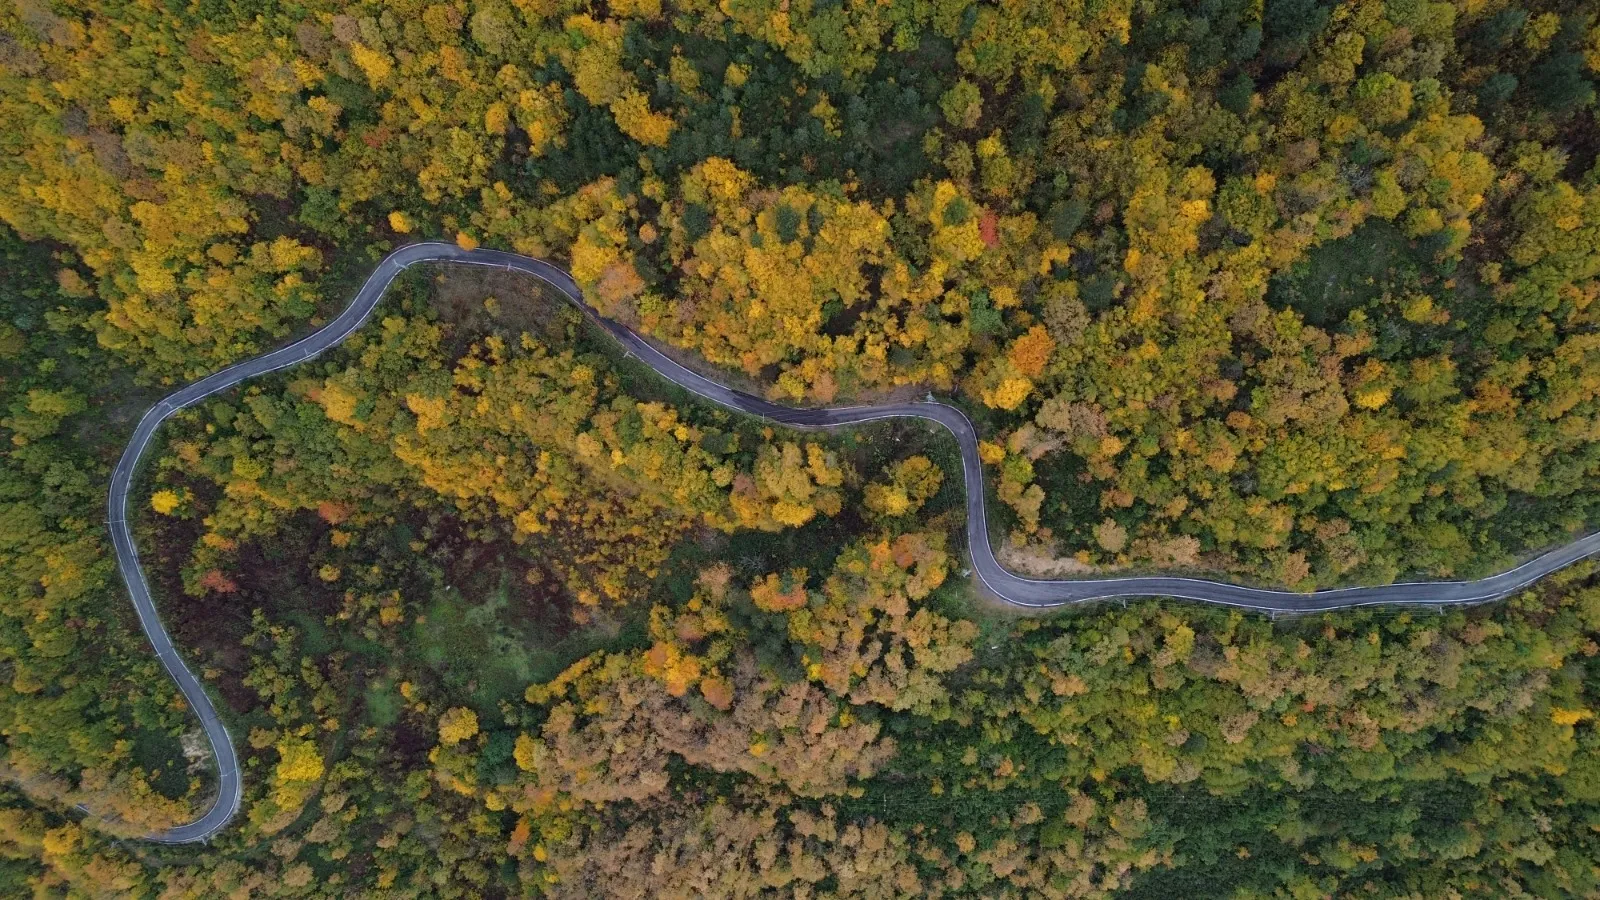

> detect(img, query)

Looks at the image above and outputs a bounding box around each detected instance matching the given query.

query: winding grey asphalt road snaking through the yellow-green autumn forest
[109,243,1600,844]
